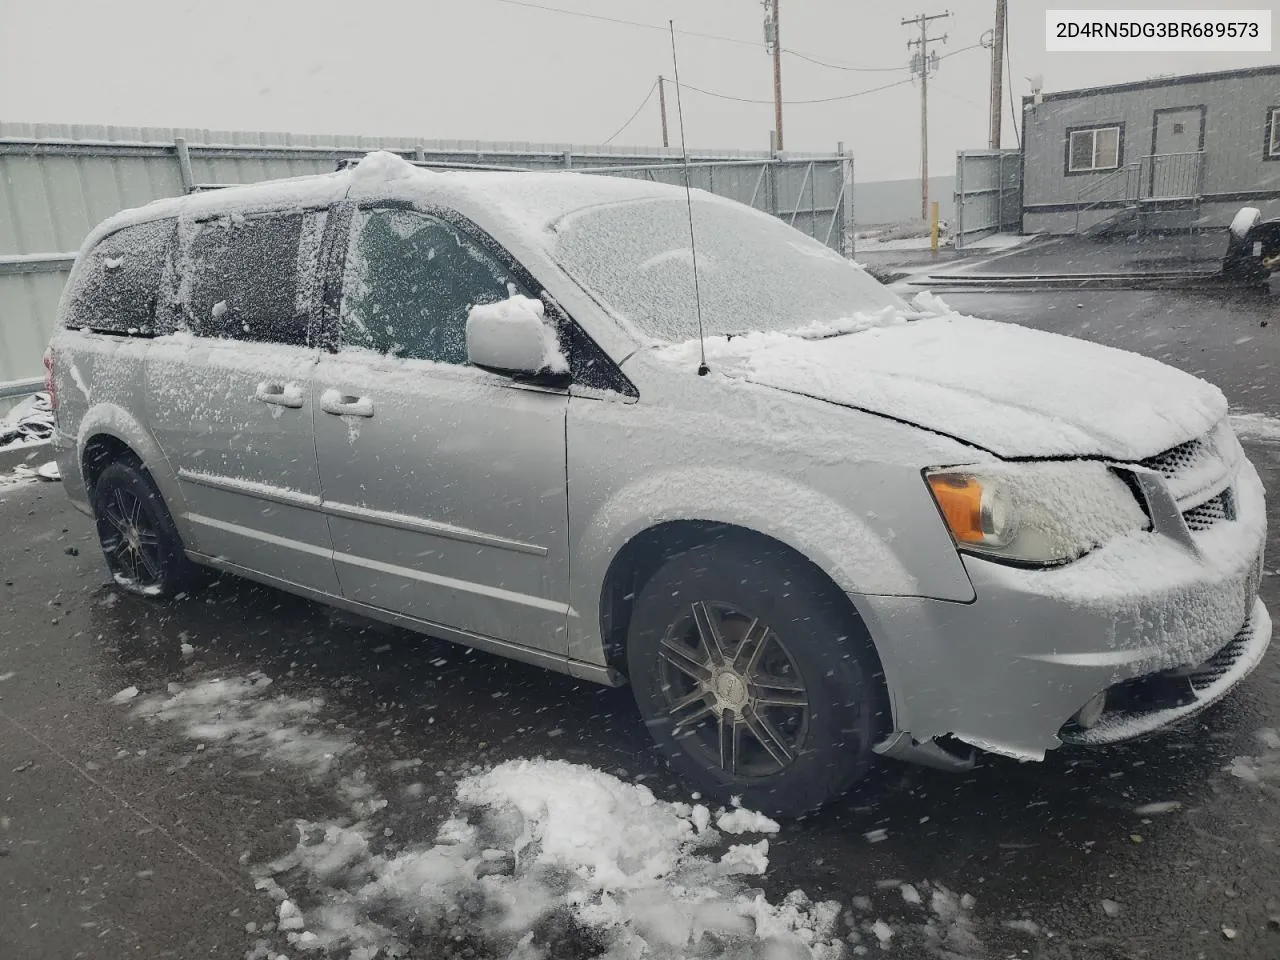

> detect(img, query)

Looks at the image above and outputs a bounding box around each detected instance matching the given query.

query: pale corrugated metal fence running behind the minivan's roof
[0,122,852,384]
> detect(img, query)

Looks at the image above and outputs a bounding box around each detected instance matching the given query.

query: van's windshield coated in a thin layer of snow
[556,196,908,343]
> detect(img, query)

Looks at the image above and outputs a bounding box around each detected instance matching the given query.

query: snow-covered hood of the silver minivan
[663,314,1226,461]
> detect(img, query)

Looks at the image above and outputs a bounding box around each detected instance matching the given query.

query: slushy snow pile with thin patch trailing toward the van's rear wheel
[124,672,849,960]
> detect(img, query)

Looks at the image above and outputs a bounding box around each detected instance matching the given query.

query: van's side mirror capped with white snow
[467,294,568,376]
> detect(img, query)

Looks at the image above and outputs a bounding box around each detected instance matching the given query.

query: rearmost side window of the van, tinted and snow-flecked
[65,220,174,334]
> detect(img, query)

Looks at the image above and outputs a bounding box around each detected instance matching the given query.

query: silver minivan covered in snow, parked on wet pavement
[47,154,1271,814]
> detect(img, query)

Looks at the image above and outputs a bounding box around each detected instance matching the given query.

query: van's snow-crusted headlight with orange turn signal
[925,461,1151,564]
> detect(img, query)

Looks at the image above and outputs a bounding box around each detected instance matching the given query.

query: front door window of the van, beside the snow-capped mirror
[340,210,524,365]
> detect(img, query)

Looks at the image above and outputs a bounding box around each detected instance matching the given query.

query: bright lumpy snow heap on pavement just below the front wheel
[259,760,844,960]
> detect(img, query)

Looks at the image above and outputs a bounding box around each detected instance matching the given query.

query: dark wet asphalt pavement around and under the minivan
[0,292,1280,960]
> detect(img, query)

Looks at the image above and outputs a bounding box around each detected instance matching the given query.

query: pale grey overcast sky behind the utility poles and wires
[0,0,1280,180]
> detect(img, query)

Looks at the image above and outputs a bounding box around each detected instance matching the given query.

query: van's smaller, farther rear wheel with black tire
[92,462,196,598]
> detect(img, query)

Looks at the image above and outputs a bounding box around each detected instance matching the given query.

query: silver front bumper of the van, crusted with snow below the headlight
[852,461,1271,760]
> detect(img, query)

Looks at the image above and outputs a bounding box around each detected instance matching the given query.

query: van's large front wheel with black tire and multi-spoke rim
[627,536,884,817]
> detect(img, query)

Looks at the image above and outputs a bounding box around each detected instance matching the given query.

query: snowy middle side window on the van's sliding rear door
[183,211,323,347]
